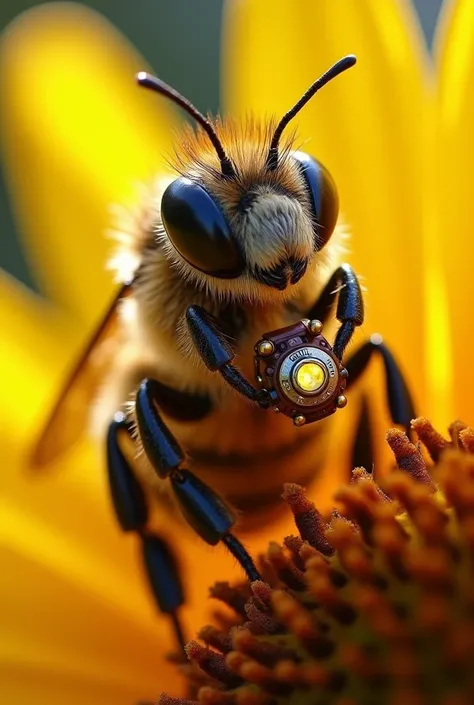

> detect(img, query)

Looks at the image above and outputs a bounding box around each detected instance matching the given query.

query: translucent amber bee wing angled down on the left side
[31,284,130,469]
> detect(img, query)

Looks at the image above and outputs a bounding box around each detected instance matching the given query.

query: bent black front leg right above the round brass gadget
[308,264,364,360]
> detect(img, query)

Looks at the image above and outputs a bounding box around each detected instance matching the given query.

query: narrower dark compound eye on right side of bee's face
[292,152,339,250]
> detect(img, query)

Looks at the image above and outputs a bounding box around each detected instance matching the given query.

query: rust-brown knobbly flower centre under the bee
[161,419,474,705]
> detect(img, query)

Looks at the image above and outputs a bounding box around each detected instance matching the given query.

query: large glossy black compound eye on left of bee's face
[161,178,244,279]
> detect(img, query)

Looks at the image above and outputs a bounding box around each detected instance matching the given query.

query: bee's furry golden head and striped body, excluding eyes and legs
[92,115,345,509]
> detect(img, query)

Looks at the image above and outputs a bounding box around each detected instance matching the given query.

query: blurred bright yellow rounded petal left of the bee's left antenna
[0,2,176,322]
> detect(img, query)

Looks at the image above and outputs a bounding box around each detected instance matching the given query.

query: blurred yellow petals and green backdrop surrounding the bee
[0,0,474,705]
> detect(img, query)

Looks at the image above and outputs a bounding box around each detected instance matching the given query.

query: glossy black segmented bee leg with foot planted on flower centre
[135,379,260,581]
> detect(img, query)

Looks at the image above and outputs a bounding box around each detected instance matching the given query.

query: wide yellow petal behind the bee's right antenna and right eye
[222,0,434,410]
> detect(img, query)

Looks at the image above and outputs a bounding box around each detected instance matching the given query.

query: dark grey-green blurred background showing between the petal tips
[0,0,441,288]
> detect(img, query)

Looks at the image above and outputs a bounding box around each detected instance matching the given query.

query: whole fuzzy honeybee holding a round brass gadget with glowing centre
[34,56,414,624]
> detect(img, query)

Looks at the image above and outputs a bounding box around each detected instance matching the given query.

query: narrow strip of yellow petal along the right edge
[432,0,474,423]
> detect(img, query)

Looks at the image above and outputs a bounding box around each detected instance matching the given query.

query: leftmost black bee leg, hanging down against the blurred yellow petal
[107,413,186,654]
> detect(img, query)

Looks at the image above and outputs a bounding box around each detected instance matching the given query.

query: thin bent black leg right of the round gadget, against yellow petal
[346,335,416,432]
